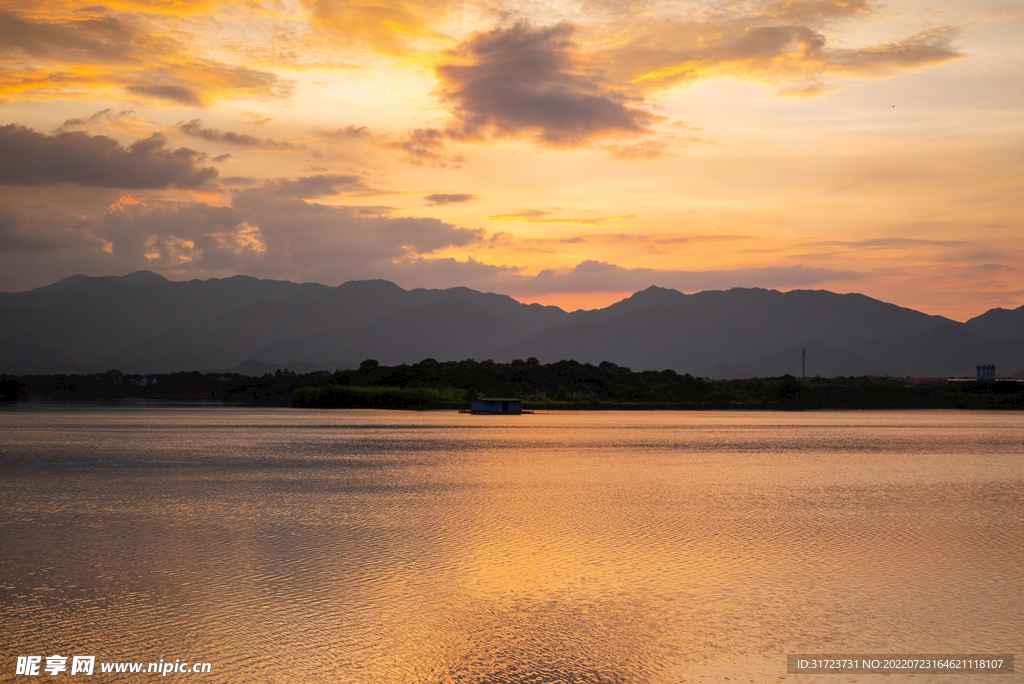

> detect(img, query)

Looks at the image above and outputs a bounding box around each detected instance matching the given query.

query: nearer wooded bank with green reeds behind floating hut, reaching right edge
[293,358,1024,410]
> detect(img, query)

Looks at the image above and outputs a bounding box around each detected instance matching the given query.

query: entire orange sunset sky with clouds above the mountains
[0,0,1024,320]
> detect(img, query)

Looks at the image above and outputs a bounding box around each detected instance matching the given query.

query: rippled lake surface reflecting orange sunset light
[0,405,1024,684]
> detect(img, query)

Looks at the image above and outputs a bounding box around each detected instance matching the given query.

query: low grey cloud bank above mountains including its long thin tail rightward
[0,192,888,296]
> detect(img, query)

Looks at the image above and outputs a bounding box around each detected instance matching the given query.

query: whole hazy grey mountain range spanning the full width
[0,271,1024,378]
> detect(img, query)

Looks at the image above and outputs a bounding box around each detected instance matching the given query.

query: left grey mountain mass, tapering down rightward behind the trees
[0,273,572,374]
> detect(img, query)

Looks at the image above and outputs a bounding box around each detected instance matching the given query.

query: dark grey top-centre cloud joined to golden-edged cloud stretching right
[381,7,963,158]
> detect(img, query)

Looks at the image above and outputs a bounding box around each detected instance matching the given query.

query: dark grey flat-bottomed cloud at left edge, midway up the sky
[0,124,217,189]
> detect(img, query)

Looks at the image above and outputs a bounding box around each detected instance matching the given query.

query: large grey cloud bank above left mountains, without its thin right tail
[0,184,483,289]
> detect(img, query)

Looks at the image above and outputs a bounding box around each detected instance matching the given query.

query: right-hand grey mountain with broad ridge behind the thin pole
[499,288,970,378]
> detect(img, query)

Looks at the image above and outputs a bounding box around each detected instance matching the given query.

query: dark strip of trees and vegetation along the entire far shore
[8,358,1024,411]
